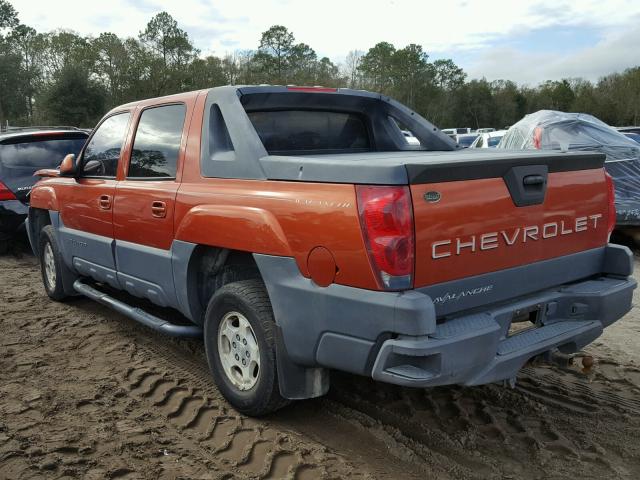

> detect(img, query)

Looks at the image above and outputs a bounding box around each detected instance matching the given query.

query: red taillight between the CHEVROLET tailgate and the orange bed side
[356,185,415,290]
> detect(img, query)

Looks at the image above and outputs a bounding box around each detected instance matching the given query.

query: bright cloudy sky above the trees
[9,0,640,85]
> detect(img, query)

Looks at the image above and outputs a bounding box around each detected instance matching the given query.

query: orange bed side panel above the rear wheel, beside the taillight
[175,180,377,289]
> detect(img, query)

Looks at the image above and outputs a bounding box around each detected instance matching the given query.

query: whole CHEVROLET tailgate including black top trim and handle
[407,154,608,287]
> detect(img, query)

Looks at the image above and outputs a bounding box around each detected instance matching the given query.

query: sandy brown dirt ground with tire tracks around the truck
[0,242,640,479]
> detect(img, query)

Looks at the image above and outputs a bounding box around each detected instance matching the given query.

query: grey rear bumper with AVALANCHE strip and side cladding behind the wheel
[254,245,636,387]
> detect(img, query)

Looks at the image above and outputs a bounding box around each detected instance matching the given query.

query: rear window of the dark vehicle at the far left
[0,136,86,168]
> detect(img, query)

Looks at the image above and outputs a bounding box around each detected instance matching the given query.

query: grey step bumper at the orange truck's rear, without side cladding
[371,277,636,387]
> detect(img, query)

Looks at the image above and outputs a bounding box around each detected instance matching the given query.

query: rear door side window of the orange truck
[127,105,187,179]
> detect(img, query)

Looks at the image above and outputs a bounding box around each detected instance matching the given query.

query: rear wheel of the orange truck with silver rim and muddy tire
[204,279,289,416]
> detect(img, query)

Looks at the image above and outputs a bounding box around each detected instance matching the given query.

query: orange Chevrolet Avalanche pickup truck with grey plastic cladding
[27,86,636,415]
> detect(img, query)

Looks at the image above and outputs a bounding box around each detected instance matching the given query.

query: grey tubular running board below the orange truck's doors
[73,280,202,337]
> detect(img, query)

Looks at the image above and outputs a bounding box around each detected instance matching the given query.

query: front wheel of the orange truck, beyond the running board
[38,225,72,302]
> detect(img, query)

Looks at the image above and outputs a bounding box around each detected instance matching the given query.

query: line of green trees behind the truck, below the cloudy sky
[0,0,640,128]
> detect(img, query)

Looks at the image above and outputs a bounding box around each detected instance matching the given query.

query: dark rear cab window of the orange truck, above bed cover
[247,110,371,154]
